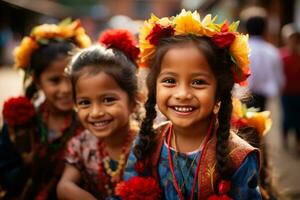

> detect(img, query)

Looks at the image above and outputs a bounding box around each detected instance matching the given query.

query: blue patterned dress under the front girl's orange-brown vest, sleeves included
[124,124,261,200]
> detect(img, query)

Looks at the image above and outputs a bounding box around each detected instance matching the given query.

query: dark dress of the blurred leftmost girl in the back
[0,103,82,199]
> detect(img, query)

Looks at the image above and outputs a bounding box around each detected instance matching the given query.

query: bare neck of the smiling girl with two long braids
[171,121,210,153]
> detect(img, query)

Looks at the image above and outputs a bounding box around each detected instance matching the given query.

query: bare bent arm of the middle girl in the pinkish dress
[57,164,96,200]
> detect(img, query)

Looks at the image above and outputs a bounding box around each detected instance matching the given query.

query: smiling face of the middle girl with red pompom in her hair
[75,72,133,138]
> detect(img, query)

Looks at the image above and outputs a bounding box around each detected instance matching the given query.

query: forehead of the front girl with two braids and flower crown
[160,44,212,75]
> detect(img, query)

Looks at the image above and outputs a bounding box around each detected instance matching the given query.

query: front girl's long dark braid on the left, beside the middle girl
[133,91,156,174]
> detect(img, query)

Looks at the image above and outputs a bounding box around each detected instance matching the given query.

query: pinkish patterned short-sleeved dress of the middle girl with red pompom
[65,130,131,199]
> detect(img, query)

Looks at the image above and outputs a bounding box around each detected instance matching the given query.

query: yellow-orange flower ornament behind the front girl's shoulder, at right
[231,98,272,137]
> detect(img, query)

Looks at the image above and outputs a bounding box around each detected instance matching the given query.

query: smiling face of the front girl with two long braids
[156,45,217,128]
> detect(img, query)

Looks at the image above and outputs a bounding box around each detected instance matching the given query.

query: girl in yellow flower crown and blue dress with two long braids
[116,10,261,200]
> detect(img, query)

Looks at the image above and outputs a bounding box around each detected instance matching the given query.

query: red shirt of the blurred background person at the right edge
[280,48,300,95]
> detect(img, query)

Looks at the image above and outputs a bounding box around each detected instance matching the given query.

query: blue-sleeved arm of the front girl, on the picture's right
[230,153,262,200]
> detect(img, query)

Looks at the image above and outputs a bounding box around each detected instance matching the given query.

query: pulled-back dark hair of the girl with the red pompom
[69,45,137,103]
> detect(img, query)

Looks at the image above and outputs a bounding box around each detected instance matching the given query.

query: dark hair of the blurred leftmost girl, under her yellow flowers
[25,40,75,99]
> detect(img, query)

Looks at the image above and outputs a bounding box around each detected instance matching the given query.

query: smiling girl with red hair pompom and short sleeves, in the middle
[57,30,139,199]
